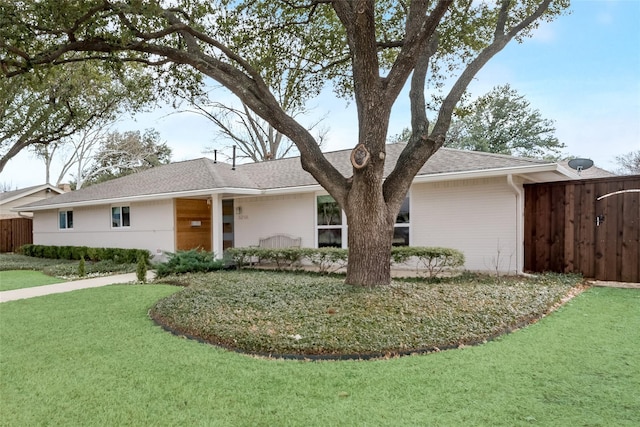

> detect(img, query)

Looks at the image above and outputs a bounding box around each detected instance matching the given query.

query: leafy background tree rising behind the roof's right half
[445,84,565,159]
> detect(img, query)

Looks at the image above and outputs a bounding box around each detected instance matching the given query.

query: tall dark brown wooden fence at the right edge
[524,175,640,282]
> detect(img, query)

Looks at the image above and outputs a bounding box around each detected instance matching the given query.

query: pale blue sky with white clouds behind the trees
[0,0,640,188]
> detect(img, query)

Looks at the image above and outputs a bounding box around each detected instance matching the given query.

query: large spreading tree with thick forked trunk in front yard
[0,0,569,286]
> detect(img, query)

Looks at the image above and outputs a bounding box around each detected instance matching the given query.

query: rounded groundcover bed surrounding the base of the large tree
[150,271,581,358]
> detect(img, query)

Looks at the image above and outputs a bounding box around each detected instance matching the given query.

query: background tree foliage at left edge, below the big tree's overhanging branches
[0,60,151,172]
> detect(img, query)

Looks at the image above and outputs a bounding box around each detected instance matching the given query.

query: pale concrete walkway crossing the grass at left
[0,271,155,303]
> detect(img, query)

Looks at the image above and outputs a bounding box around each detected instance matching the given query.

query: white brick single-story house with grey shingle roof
[15,144,596,273]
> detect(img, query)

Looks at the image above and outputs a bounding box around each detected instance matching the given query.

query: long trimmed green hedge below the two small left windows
[18,244,151,264]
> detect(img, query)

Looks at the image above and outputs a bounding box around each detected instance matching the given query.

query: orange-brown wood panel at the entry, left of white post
[175,199,211,251]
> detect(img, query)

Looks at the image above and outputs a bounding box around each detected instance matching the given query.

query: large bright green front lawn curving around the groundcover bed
[0,285,640,426]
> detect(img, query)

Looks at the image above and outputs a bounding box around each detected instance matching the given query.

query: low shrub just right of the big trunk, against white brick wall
[391,246,464,277]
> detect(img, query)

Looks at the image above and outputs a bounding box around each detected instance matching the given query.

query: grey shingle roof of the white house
[18,143,577,210]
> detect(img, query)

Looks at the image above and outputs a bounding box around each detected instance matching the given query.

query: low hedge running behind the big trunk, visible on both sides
[226,246,464,277]
